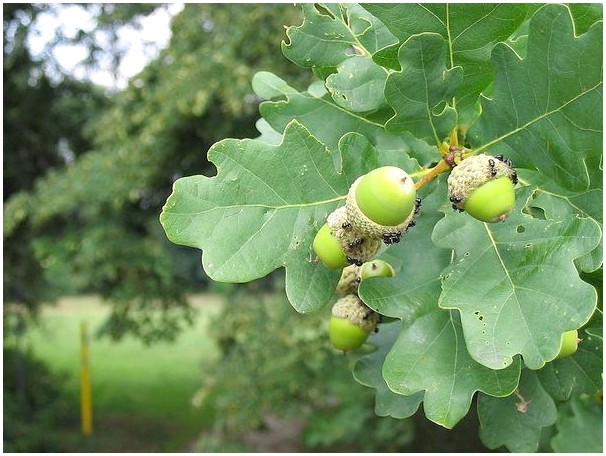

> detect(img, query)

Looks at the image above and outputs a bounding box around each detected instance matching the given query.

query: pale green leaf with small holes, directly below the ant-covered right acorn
[433,188,601,369]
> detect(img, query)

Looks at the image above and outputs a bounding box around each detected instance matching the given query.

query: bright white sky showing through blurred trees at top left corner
[29,3,183,89]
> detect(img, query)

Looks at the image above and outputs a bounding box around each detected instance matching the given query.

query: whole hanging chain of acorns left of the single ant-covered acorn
[313,166,421,352]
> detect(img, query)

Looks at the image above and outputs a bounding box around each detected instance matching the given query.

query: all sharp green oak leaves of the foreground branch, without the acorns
[161,0,602,451]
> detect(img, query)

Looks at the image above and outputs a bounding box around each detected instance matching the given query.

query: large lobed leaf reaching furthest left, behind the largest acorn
[160,121,420,312]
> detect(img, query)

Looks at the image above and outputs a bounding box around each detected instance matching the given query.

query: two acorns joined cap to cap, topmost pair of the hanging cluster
[313,166,421,269]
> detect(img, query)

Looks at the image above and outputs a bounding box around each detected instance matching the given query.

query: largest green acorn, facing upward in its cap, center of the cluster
[345,166,419,244]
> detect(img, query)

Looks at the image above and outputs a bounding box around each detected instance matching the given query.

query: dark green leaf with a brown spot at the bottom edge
[478,369,557,452]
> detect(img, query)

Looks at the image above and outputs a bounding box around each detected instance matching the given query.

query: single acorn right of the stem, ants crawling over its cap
[448,154,517,223]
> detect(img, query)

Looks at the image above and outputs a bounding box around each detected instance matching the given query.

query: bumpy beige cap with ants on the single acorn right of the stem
[448,154,514,210]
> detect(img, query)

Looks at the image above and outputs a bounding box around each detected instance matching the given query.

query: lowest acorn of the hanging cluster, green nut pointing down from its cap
[328,294,380,352]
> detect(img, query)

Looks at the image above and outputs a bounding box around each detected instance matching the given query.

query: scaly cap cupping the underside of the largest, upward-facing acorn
[345,176,417,243]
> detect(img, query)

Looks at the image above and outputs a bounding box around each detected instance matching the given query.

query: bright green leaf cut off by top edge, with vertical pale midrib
[363,3,528,125]
